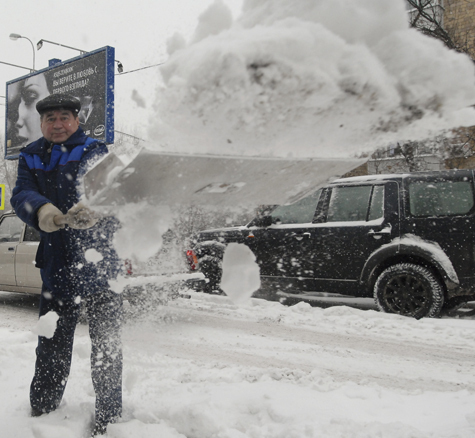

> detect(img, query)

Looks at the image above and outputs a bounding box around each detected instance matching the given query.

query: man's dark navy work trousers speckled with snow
[30,290,122,425]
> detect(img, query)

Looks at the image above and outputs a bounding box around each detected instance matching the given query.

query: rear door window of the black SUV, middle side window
[327,185,384,222]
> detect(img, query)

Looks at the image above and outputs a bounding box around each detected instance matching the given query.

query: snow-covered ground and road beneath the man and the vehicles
[0,292,475,438]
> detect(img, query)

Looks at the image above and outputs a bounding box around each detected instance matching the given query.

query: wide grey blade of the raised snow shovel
[84,149,365,208]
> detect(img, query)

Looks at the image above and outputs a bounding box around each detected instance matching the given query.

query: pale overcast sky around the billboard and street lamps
[0,0,242,137]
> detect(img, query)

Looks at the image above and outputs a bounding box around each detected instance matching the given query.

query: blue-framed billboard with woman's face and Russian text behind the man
[5,46,115,159]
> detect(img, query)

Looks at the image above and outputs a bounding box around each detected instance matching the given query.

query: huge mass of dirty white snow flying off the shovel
[150,0,475,157]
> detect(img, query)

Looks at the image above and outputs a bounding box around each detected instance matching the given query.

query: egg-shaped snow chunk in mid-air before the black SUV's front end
[220,243,261,304]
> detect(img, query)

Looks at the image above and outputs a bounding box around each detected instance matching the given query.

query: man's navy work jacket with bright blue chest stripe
[10,128,120,299]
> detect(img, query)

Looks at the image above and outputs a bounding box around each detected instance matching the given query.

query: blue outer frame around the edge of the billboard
[4,46,115,160]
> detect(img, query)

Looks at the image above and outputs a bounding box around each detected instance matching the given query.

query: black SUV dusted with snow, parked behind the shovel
[188,170,475,318]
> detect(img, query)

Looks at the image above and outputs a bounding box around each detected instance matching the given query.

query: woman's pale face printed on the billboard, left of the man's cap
[16,74,50,146]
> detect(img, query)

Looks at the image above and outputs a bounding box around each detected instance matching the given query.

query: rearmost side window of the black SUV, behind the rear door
[409,181,473,217]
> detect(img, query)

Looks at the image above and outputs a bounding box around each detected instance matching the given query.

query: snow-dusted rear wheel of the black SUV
[374,263,444,319]
